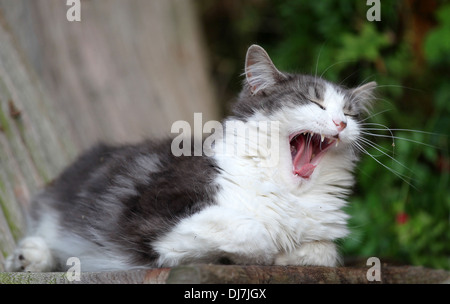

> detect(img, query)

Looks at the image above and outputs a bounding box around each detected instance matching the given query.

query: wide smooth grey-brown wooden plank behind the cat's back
[0,0,218,149]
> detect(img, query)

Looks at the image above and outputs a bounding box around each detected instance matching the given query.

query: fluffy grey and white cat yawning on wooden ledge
[5,45,376,272]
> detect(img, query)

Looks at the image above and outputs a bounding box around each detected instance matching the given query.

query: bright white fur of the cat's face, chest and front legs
[154,86,358,266]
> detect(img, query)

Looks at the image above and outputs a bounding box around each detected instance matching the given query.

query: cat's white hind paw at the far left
[5,237,53,272]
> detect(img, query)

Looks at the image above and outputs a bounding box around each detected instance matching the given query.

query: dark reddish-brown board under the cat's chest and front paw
[163,265,450,284]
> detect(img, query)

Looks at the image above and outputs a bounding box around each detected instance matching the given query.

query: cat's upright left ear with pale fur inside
[245,44,286,95]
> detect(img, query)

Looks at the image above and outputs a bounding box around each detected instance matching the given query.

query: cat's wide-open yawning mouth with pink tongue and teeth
[289,131,339,178]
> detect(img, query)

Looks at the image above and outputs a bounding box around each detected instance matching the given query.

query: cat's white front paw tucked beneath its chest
[275,241,340,267]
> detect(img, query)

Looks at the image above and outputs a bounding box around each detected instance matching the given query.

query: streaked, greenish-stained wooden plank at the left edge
[0,6,73,262]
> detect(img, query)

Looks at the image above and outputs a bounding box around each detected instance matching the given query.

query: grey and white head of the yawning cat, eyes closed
[233,45,376,185]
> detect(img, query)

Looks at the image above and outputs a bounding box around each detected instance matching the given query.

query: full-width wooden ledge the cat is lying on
[0,265,450,284]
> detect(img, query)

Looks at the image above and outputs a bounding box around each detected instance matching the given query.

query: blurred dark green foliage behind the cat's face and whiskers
[201,0,450,269]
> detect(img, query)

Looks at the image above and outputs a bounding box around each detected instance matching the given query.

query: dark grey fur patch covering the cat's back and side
[32,139,218,266]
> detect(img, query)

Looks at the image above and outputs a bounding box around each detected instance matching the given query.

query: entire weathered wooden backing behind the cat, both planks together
[0,0,219,270]
